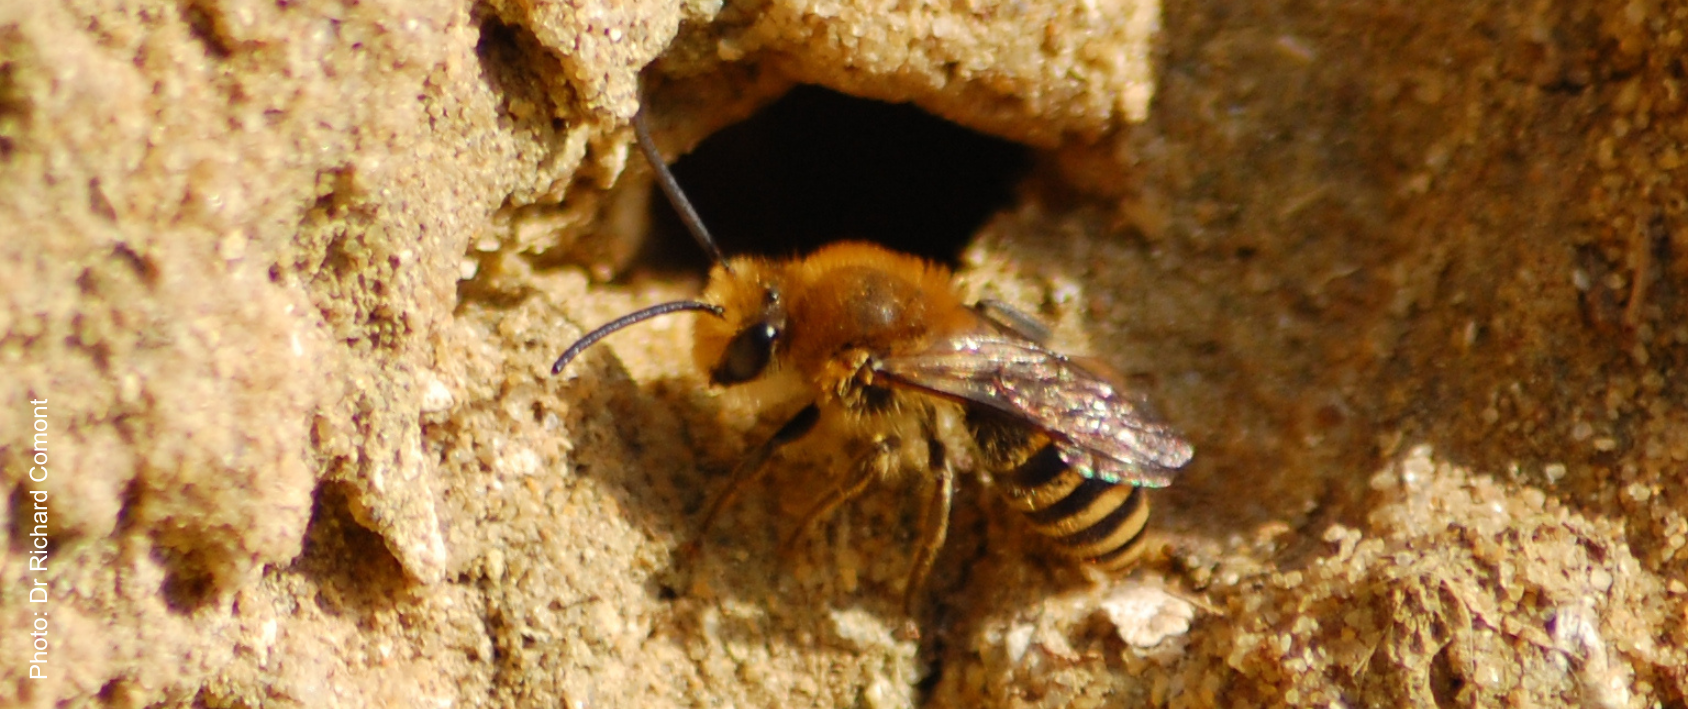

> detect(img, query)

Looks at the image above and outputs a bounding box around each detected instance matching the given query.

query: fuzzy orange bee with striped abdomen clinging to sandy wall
[552,105,1192,614]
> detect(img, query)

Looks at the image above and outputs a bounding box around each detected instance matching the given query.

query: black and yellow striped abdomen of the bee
[967,410,1150,571]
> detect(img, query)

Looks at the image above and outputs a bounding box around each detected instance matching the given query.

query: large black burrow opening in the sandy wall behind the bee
[640,86,1031,270]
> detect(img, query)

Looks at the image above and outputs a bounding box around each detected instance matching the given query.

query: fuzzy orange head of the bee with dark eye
[692,258,787,387]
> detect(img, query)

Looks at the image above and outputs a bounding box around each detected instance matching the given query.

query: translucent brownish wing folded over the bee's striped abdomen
[876,333,1192,488]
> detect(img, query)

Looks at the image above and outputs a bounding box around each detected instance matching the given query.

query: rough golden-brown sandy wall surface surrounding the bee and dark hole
[0,0,1688,707]
